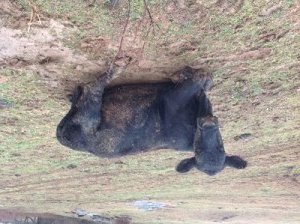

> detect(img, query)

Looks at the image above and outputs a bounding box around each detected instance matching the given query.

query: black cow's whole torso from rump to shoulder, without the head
[57,67,212,157]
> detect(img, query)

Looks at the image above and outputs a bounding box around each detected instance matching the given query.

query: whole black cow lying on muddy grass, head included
[57,67,246,175]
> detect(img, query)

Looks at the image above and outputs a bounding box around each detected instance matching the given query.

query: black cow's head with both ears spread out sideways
[176,116,247,175]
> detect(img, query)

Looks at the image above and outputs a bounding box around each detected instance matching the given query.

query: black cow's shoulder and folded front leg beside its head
[159,69,212,150]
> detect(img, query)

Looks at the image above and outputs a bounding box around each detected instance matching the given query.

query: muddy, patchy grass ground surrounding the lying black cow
[0,0,300,224]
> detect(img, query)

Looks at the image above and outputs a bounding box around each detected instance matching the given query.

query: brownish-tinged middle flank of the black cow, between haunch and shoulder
[94,82,174,156]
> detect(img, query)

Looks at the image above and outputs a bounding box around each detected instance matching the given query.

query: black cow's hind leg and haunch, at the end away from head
[56,66,115,151]
